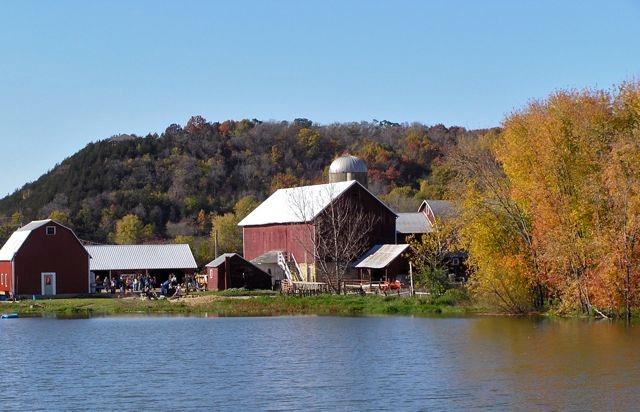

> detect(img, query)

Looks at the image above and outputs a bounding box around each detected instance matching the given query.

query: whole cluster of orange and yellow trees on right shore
[458,83,640,316]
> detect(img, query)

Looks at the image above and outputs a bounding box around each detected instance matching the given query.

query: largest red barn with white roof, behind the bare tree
[239,180,397,280]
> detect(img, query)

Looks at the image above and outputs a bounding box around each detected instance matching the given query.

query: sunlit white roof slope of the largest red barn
[238,180,359,226]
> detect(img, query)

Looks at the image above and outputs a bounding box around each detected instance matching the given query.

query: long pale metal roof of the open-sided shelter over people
[85,244,198,270]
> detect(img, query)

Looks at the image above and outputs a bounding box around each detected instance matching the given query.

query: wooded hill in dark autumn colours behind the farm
[0,116,490,248]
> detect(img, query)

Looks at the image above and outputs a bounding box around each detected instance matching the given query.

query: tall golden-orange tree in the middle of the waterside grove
[498,91,613,312]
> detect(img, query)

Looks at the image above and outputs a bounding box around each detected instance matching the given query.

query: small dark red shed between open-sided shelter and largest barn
[206,253,272,290]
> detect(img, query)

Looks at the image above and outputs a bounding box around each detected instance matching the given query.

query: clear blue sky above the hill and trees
[0,0,640,195]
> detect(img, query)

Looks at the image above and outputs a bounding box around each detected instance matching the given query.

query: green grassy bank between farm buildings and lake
[0,294,474,316]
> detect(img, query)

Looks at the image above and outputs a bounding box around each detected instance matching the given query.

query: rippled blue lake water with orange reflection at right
[0,317,640,411]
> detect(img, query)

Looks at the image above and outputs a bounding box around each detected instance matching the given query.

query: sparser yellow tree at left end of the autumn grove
[452,133,544,313]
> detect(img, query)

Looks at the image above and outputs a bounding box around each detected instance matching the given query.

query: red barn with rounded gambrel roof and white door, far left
[0,220,90,296]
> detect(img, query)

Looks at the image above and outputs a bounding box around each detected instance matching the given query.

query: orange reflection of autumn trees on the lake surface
[452,317,640,409]
